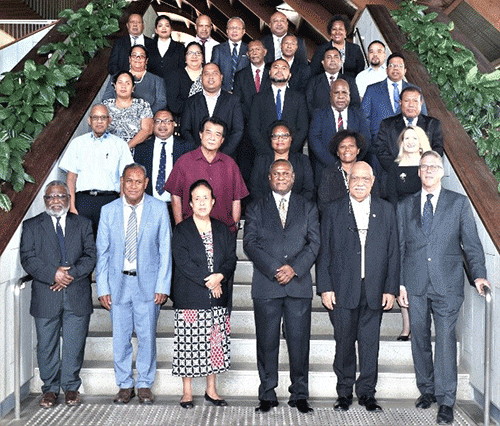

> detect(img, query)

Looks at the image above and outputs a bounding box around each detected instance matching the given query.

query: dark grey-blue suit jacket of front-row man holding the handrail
[398,188,486,298]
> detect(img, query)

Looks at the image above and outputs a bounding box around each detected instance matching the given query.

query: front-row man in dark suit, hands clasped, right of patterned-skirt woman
[243,159,320,413]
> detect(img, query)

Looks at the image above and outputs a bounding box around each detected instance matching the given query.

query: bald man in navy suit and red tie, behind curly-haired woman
[308,79,370,187]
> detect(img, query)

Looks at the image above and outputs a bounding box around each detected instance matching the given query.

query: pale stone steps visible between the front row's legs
[30,226,472,400]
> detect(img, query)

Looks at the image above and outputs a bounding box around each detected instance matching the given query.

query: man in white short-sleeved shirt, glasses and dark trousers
[59,104,134,237]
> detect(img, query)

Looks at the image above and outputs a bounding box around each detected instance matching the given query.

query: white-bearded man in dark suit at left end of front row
[20,181,96,408]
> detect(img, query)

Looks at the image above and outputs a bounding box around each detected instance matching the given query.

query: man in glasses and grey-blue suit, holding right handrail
[398,151,490,424]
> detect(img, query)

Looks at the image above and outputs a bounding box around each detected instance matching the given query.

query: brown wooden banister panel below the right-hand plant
[367,6,500,251]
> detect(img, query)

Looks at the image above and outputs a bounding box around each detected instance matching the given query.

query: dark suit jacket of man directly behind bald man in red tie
[306,73,361,116]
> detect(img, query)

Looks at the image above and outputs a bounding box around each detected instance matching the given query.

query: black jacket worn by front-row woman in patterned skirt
[172,216,237,309]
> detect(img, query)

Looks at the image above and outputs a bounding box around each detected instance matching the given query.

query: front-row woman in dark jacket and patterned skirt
[171,180,237,408]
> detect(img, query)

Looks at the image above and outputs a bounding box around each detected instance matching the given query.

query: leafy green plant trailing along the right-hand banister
[392,0,500,191]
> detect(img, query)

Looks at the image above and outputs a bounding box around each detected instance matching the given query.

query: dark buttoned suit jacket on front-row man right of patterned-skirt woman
[243,192,319,299]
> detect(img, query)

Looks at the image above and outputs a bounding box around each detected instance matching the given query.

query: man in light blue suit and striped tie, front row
[96,163,172,404]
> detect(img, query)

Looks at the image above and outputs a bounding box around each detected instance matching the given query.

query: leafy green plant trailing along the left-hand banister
[0,0,127,211]
